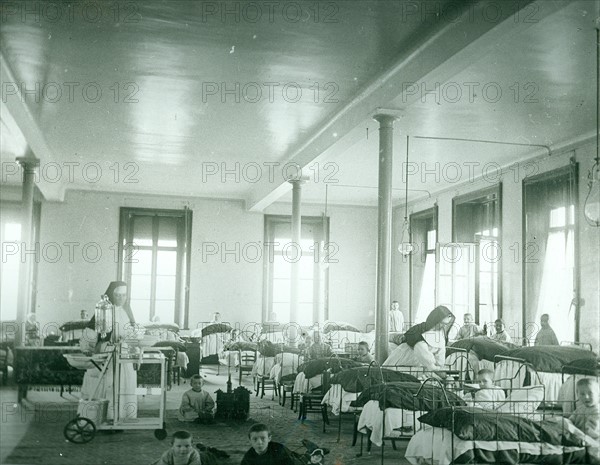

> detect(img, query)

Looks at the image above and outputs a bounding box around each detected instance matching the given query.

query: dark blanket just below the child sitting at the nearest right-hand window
[503,346,597,373]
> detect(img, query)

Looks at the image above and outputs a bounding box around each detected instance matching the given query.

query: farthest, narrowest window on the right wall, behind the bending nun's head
[410,206,437,323]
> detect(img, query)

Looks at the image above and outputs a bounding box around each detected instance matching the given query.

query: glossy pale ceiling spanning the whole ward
[0,0,600,210]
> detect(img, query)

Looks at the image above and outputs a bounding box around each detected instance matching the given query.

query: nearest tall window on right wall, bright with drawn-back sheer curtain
[522,164,579,341]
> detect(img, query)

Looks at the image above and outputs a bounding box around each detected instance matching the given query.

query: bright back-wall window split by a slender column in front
[264,215,330,325]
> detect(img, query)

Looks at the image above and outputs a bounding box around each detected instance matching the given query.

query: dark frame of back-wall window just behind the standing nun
[117,206,193,329]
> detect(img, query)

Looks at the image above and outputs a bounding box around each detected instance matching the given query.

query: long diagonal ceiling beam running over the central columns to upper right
[246,0,569,211]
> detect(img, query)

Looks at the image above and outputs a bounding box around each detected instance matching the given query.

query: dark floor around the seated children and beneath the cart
[0,366,408,465]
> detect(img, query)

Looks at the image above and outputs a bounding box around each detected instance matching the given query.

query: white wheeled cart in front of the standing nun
[63,344,167,444]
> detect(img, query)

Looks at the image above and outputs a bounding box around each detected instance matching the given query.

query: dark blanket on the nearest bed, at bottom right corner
[419,407,583,446]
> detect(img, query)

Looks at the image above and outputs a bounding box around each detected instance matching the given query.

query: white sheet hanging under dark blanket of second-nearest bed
[357,400,424,446]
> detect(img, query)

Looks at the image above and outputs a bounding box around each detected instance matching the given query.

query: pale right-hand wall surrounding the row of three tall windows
[392,143,600,350]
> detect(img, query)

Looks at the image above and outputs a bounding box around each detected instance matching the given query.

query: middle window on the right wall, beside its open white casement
[452,184,502,325]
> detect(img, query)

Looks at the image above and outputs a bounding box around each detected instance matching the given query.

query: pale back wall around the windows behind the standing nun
[21,191,377,334]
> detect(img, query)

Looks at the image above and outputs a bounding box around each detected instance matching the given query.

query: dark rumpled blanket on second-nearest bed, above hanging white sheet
[352,381,466,411]
